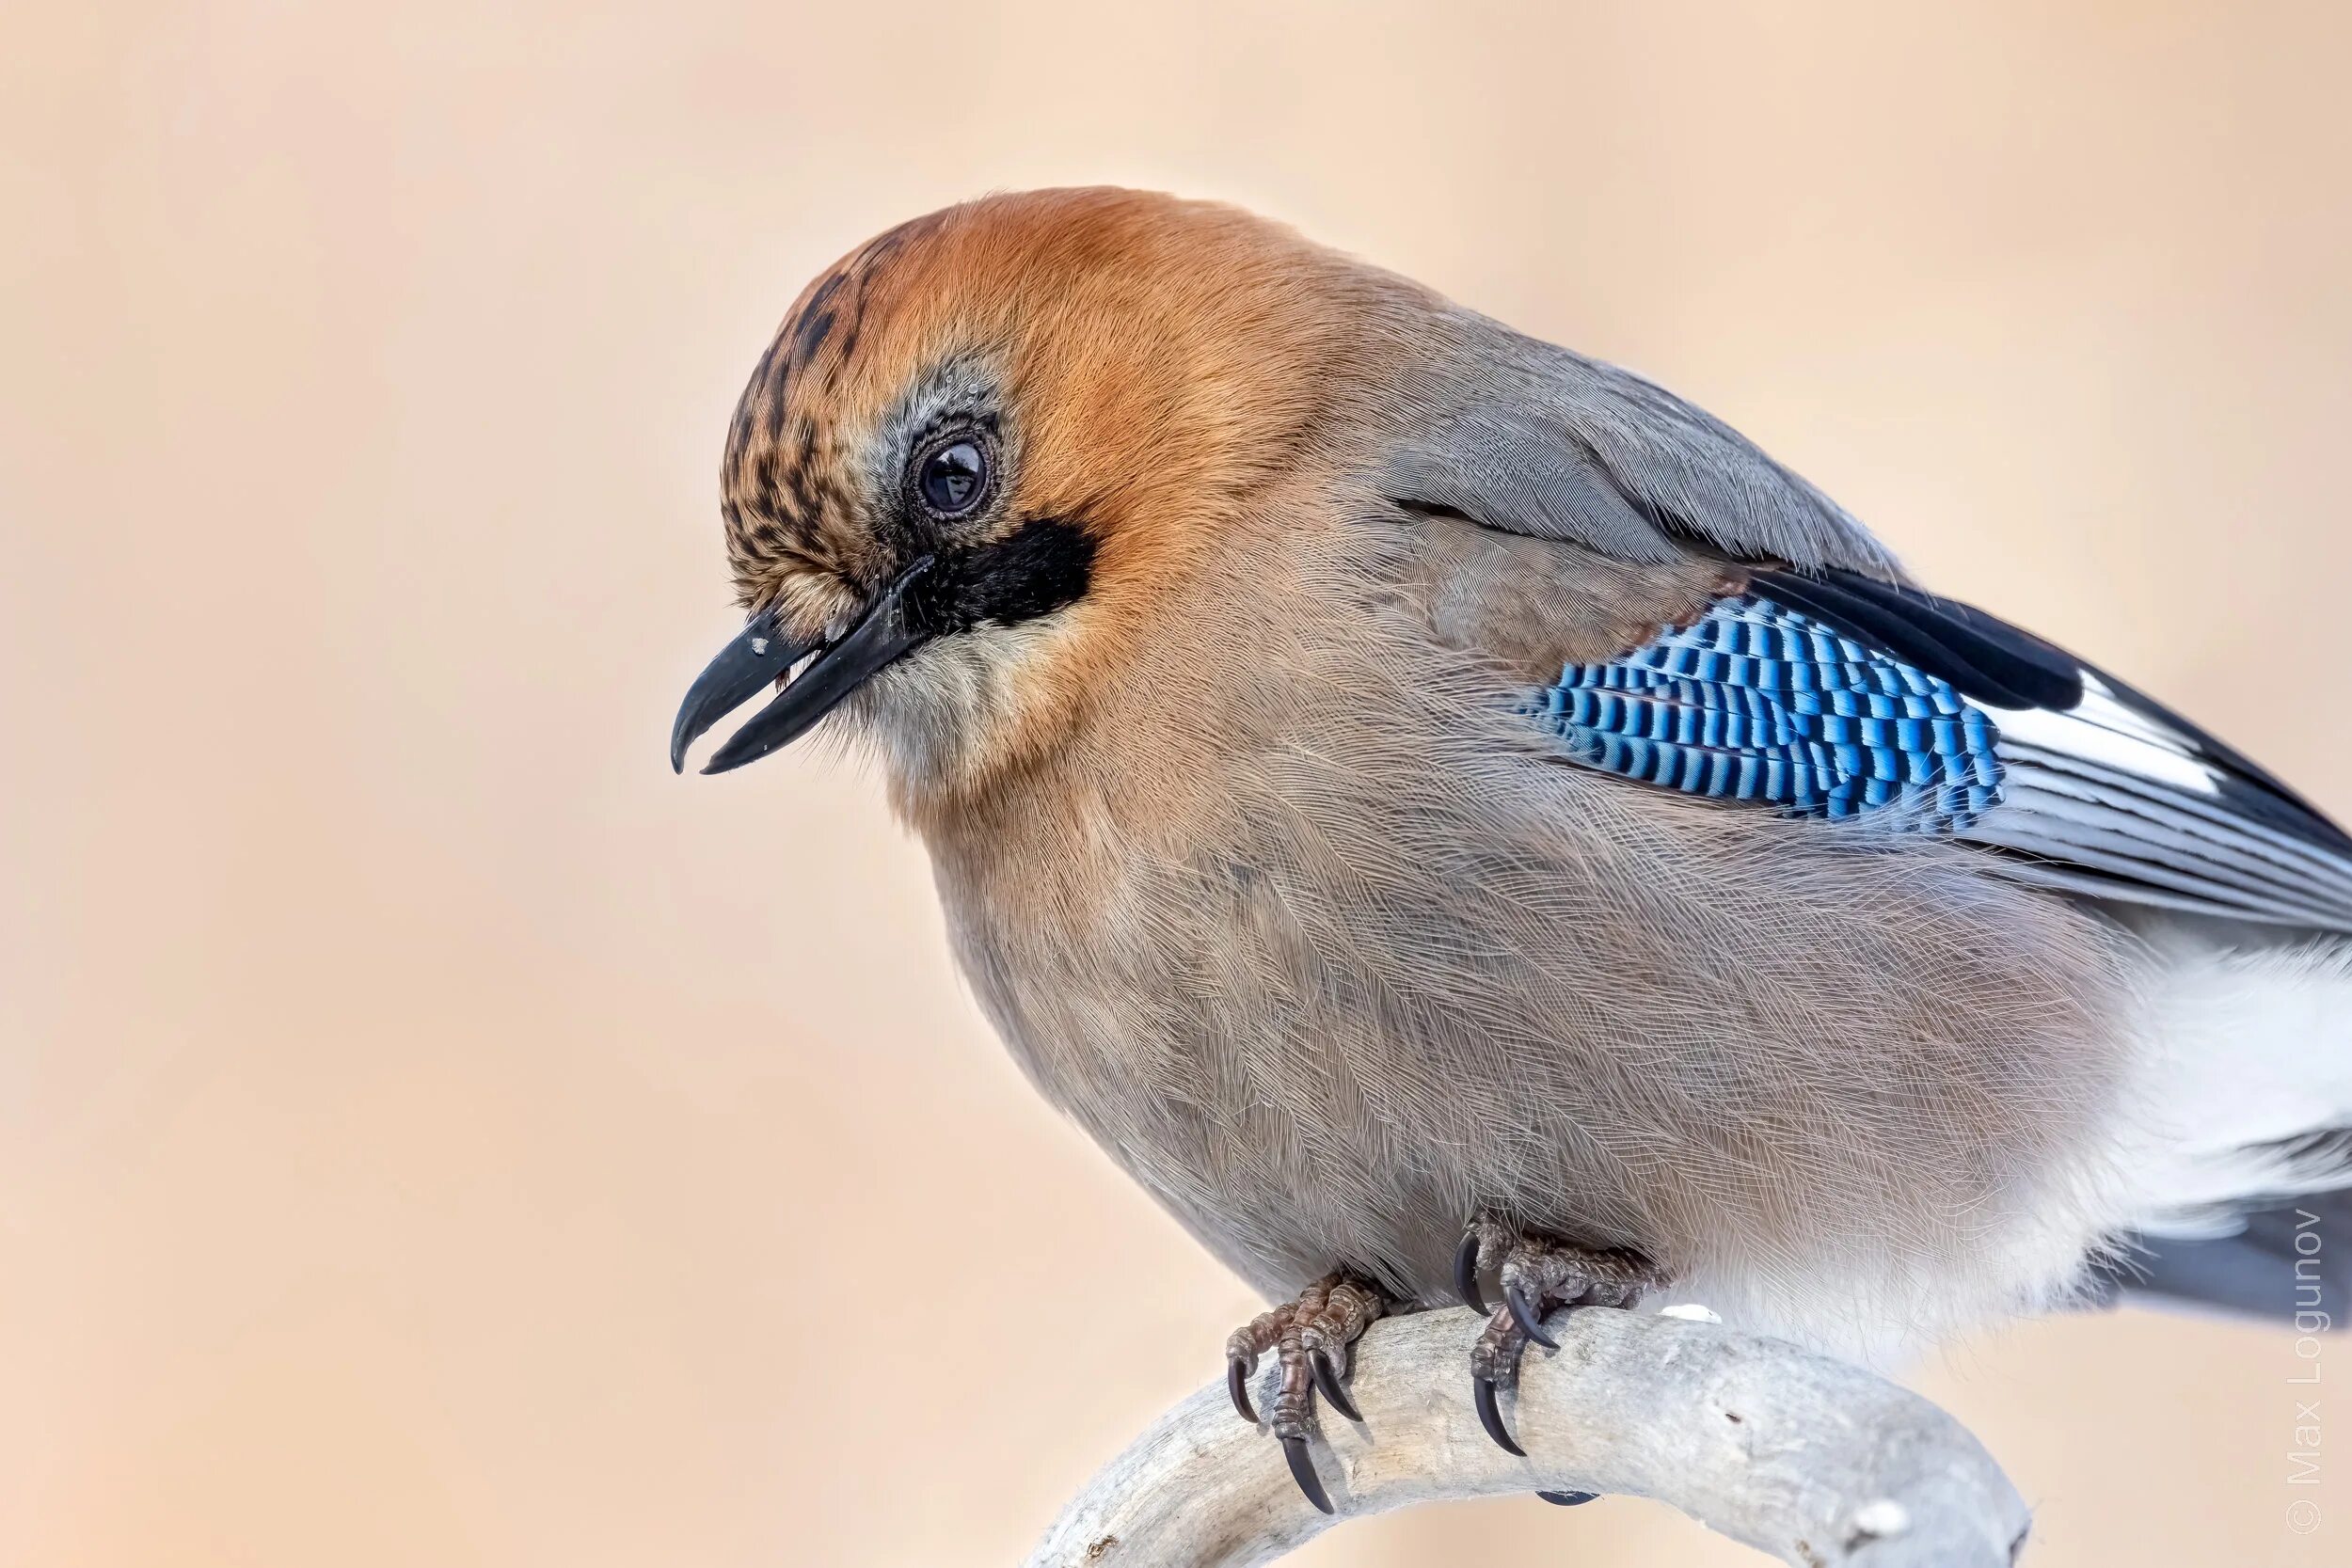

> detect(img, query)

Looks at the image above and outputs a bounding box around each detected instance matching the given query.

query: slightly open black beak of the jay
[671,555,931,773]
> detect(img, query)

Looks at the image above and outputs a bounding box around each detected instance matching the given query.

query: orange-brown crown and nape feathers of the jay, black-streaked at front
[723,188,1402,620]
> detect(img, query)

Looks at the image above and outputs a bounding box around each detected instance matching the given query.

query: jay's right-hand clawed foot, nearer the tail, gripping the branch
[1454,1215,1668,1466]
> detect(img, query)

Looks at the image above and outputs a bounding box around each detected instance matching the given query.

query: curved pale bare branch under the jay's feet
[1030,1309,2027,1568]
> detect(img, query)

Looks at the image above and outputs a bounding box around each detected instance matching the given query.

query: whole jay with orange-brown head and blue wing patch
[671,190,2352,1507]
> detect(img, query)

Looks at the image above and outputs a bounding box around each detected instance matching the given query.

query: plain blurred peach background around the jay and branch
[0,0,2352,1568]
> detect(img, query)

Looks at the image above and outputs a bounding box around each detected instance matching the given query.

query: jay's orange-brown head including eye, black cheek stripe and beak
[671,190,1364,797]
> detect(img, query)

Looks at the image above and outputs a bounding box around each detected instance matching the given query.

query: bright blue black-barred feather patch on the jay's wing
[1534,594,2002,834]
